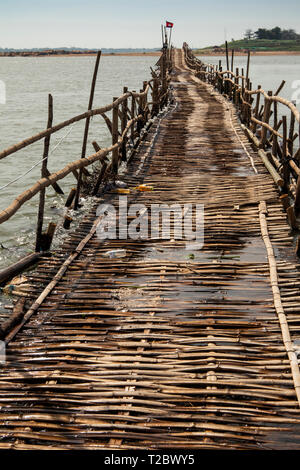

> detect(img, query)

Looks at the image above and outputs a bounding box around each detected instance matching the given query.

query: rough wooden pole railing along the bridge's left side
[0,47,172,272]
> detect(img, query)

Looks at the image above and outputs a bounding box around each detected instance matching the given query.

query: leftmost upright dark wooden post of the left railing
[35,94,53,252]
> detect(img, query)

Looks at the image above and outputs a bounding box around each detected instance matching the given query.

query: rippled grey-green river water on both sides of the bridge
[0,52,300,267]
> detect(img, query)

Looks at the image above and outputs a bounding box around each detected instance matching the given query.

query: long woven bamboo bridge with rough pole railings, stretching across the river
[0,44,300,450]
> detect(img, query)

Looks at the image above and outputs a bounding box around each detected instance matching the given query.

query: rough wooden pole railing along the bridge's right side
[183,43,300,228]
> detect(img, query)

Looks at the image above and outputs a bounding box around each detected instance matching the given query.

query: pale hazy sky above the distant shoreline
[0,0,300,49]
